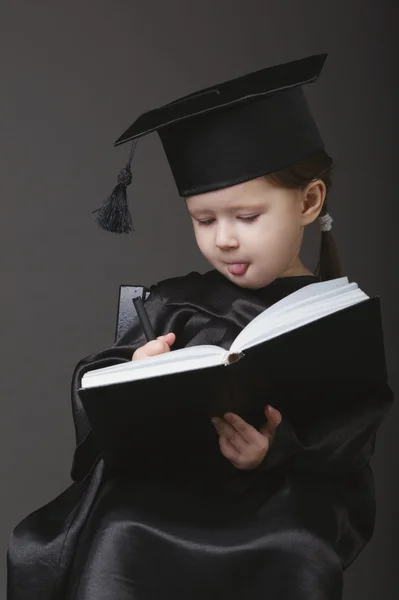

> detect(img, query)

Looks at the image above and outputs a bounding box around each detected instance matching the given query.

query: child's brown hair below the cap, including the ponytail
[266,150,343,281]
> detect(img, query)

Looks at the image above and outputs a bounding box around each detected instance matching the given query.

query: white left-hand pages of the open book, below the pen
[82,344,226,388]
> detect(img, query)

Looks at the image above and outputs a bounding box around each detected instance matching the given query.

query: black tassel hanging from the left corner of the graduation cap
[93,140,137,233]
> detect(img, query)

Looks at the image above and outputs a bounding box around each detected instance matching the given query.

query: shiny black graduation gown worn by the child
[8,271,393,600]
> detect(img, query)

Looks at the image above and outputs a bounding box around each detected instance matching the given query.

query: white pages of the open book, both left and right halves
[82,277,369,388]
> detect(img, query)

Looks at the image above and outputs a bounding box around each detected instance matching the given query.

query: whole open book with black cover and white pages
[78,277,387,470]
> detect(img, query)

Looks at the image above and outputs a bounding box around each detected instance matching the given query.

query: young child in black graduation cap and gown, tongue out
[8,55,392,600]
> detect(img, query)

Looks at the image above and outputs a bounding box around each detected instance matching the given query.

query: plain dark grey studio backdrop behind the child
[0,0,399,600]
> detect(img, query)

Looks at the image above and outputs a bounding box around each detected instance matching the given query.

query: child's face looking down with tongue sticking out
[186,177,313,288]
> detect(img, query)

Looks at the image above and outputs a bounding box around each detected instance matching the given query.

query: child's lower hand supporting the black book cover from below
[212,404,282,469]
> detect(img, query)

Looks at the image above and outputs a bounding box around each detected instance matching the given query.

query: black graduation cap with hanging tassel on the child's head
[93,54,327,233]
